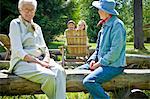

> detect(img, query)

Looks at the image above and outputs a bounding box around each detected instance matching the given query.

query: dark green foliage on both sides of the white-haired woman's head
[0,0,75,44]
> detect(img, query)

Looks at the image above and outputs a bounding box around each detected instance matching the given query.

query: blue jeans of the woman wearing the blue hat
[77,64,124,99]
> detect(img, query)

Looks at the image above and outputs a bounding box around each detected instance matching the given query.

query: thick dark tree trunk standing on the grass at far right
[134,0,145,49]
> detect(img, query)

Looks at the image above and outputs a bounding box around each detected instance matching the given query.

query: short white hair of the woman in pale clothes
[18,0,37,10]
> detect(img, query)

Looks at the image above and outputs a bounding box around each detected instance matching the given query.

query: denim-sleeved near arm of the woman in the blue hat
[98,23,126,65]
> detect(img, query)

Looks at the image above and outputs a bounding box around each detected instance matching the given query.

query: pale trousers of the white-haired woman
[13,61,66,99]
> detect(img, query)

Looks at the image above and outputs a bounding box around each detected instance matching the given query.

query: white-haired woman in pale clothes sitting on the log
[9,0,66,99]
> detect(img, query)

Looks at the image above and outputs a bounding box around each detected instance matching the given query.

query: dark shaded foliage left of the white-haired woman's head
[0,0,18,34]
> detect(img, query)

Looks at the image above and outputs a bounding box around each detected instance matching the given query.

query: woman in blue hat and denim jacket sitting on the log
[78,0,126,99]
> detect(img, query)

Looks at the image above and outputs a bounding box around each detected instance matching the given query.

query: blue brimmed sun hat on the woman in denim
[92,0,119,15]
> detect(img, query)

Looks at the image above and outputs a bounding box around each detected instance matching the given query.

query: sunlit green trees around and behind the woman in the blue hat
[64,0,150,42]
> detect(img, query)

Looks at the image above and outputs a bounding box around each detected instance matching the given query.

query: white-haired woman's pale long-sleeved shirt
[9,18,48,72]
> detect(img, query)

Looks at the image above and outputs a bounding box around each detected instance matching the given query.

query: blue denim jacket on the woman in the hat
[88,16,126,67]
